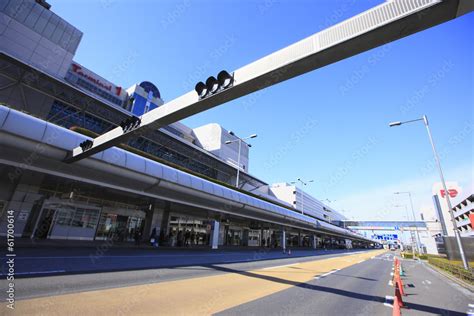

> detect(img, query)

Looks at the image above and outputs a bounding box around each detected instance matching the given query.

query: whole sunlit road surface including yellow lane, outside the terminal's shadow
[0,251,474,315]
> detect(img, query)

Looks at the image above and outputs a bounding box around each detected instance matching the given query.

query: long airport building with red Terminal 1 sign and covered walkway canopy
[0,0,373,248]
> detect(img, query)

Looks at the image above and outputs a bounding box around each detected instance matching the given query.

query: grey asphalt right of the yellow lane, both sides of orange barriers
[218,254,474,316]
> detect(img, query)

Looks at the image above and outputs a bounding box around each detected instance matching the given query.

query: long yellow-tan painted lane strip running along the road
[15,250,385,315]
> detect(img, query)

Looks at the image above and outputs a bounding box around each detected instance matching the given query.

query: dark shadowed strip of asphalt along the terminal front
[0,246,370,278]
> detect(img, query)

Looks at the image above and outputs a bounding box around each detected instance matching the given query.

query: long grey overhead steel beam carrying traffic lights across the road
[65,0,474,162]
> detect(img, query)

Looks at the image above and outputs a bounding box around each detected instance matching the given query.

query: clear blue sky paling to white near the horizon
[48,0,474,220]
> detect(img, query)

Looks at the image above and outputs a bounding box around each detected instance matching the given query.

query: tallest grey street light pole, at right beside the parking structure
[389,115,469,270]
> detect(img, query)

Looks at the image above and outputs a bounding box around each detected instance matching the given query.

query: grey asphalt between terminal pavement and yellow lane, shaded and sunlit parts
[0,249,373,299]
